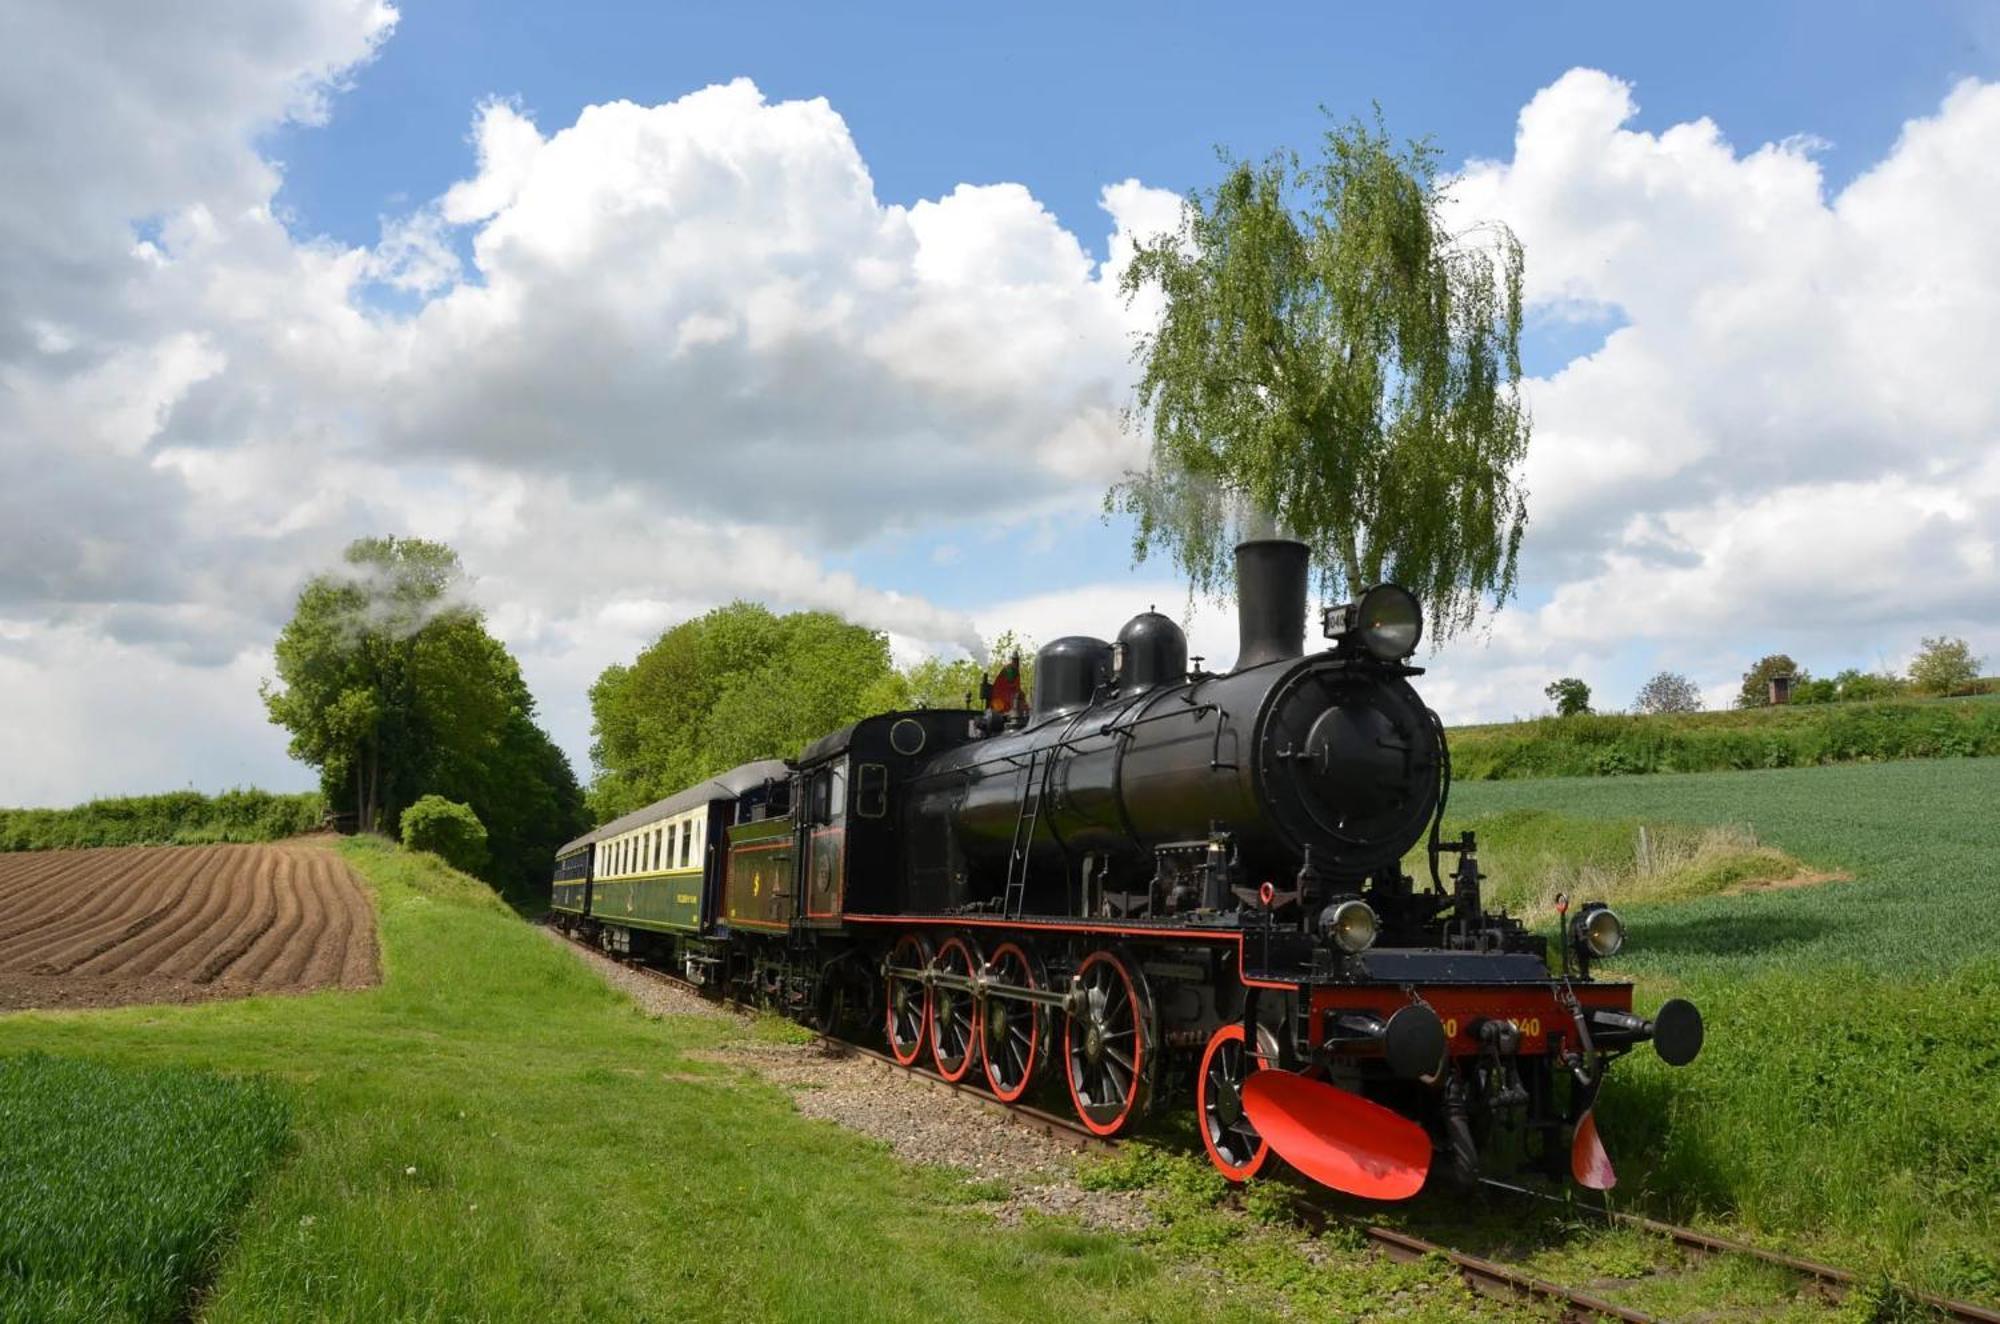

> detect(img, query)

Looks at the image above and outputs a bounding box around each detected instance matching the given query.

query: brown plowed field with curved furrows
[0,842,380,1010]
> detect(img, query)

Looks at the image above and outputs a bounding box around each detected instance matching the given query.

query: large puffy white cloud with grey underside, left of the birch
[378,80,1170,544]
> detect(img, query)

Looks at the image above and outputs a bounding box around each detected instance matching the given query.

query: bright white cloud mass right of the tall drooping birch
[1448,70,2000,716]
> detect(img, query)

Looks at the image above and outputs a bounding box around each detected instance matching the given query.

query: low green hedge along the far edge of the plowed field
[0,790,326,850]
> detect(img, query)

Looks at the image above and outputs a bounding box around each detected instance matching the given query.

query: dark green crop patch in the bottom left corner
[0,1054,290,1324]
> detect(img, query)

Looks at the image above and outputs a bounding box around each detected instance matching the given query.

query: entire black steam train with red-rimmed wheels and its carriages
[554,540,1702,1198]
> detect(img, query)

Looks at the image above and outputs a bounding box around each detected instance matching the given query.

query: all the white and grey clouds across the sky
[0,0,2000,802]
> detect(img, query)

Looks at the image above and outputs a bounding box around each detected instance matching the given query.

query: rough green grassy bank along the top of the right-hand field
[1450,696,2000,782]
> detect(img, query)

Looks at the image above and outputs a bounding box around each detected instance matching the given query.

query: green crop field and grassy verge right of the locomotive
[1448,760,2000,1300]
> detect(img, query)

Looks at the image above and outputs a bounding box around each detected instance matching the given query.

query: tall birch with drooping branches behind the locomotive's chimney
[1106,114,1530,640]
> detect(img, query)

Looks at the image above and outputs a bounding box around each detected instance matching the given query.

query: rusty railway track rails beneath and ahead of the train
[556,930,2000,1324]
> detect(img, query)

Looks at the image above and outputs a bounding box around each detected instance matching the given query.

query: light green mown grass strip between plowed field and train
[0,840,1504,1324]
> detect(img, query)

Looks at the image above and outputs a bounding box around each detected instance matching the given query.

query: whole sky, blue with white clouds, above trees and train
[0,0,2000,804]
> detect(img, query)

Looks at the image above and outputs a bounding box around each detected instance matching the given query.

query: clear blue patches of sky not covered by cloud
[270,4,2000,628]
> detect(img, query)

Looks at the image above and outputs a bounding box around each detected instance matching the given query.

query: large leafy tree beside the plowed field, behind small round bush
[264,538,584,904]
